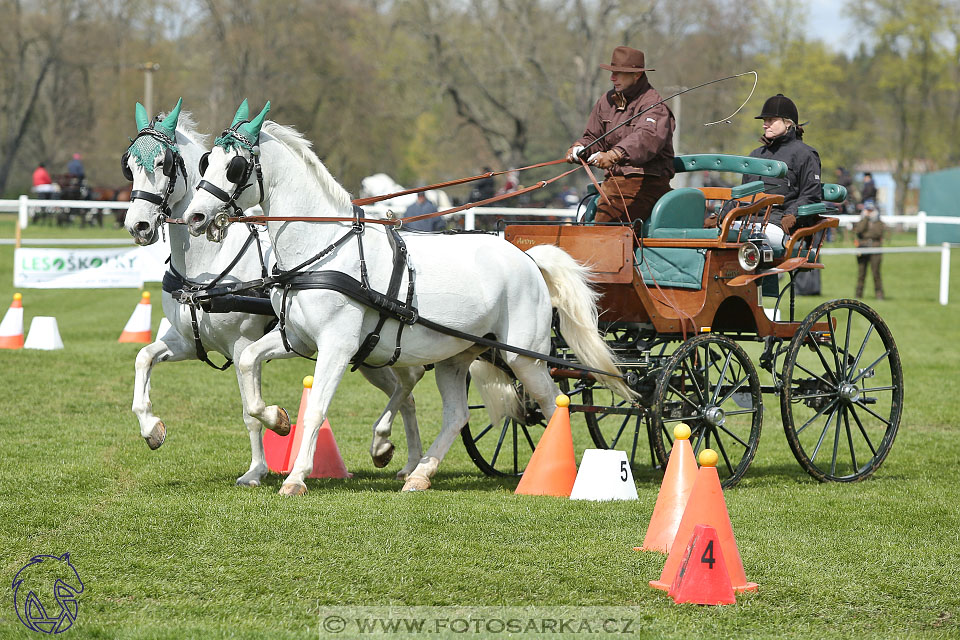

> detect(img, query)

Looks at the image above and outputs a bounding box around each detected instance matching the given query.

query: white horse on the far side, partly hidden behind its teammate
[123,102,423,486]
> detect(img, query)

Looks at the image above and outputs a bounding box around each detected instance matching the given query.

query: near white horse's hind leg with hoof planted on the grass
[402,350,476,491]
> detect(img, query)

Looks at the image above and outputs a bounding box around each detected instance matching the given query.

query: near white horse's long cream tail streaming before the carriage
[527,245,636,401]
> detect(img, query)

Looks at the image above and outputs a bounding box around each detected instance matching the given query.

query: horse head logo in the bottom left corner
[11,553,83,633]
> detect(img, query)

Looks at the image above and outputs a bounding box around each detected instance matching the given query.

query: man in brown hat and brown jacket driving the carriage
[567,47,677,230]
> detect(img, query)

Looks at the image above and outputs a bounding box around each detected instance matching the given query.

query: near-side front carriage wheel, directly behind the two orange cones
[650,333,763,488]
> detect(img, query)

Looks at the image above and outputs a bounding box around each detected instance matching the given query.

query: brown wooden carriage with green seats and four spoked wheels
[463,155,903,487]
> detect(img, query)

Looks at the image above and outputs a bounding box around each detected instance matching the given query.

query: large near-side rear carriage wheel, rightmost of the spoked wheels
[780,300,903,482]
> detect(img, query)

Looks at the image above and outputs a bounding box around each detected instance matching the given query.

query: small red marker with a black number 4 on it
[668,524,737,604]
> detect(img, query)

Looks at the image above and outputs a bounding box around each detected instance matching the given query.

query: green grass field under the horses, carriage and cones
[0,219,960,640]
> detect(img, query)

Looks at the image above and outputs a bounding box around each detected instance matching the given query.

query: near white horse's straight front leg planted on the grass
[279,344,353,496]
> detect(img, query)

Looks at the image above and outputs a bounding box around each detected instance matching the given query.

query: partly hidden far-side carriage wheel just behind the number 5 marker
[577,372,666,471]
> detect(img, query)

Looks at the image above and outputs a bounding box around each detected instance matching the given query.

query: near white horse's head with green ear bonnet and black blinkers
[184,100,270,241]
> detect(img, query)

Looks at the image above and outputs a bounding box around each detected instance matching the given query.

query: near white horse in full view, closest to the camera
[184,103,630,495]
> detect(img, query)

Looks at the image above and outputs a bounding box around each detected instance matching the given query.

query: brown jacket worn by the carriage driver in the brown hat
[574,75,677,178]
